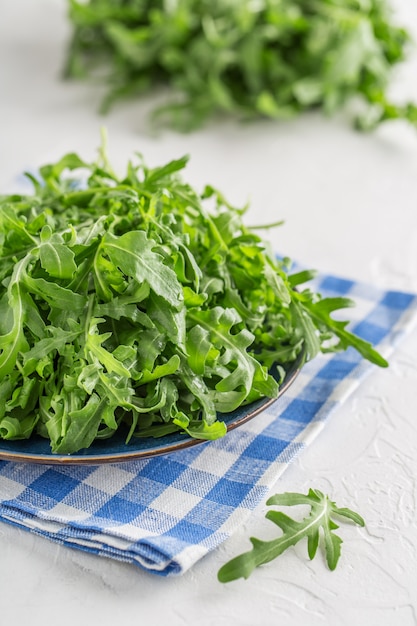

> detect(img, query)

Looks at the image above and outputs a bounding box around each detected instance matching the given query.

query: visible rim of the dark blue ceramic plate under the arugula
[0,355,303,465]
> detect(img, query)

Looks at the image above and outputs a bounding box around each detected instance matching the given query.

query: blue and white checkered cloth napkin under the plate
[0,276,417,575]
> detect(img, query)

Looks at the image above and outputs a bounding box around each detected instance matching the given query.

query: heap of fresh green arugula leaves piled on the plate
[0,143,387,454]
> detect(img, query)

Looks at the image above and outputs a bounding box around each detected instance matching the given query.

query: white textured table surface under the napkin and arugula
[0,0,417,626]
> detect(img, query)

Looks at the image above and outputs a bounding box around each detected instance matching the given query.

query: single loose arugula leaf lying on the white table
[218,489,365,583]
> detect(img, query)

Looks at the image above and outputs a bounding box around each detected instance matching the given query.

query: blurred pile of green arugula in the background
[65,0,417,130]
